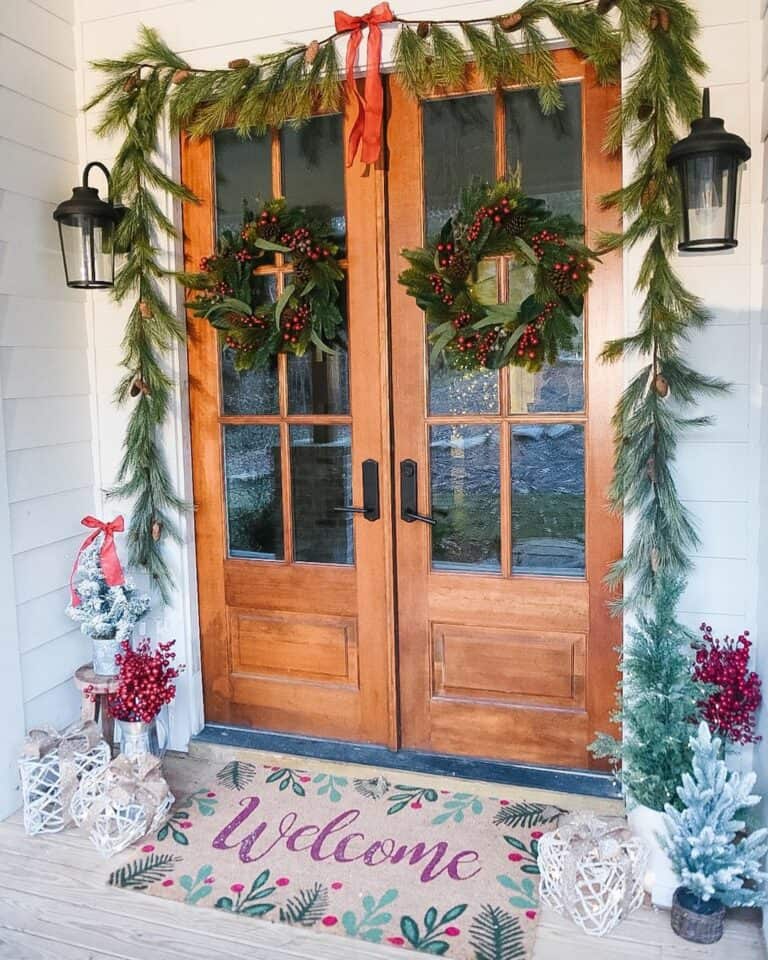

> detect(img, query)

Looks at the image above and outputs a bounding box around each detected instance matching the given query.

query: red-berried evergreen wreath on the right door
[399,176,595,371]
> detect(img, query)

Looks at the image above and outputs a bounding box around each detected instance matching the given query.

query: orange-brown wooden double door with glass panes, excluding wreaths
[182,51,621,767]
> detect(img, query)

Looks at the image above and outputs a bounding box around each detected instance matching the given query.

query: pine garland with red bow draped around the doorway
[86,0,726,607]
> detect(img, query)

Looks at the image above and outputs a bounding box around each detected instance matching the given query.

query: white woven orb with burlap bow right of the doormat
[538,815,648,937]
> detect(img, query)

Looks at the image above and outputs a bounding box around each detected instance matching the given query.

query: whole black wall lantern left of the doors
[53,163,125,290]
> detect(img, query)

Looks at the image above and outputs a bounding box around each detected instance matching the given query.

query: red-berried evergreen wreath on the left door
[181,198,344,372]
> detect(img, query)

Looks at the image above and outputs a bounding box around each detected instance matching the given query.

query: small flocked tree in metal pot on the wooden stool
[66,540,149,676]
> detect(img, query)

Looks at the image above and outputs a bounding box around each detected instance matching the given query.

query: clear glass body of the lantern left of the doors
[59,213,115,289]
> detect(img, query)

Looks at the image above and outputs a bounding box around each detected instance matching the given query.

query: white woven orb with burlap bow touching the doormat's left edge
[72,761,174,857]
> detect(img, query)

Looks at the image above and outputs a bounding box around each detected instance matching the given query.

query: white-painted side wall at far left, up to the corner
[0,0,99,818]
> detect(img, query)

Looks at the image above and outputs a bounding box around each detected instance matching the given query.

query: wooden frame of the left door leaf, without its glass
[182,92,397,746]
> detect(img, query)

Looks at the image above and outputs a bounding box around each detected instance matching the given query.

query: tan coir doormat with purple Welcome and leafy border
[109,760,563,960]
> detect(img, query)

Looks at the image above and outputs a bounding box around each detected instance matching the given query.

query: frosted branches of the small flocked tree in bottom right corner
[661,722,768,907]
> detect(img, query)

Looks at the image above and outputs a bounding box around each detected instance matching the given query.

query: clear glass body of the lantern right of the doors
[678,152,741,251]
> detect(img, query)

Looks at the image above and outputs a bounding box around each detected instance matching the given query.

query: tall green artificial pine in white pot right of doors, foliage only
[590,577,707,811]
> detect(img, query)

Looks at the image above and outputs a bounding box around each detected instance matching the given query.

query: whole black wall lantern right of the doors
[667,90,752,252]
